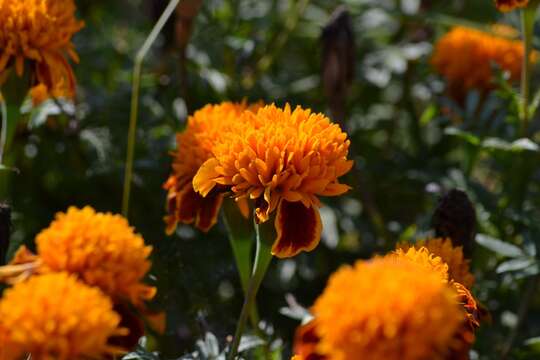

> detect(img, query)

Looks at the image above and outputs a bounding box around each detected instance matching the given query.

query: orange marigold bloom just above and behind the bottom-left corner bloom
[36,206,155,304]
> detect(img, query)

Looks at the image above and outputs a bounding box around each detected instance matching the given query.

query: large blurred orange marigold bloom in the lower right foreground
[313,256,464,360]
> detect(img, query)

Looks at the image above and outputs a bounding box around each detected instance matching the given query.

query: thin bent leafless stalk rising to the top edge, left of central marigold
[122,0,181,217]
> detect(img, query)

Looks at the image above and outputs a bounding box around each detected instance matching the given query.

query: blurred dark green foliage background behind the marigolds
[5,0,540,359]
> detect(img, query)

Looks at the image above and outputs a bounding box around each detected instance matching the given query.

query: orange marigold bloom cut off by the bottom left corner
[0,273,125,360]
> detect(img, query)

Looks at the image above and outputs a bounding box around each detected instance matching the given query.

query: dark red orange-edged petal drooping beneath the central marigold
[272,201,322,258]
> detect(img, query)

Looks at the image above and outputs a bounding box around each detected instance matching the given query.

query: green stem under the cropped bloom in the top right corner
[521,6,536,137]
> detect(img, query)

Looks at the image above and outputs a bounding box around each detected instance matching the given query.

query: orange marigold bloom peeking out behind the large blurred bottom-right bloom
[397,238,474,289]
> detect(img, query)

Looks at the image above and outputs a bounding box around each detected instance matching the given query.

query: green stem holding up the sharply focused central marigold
[227,221,275,360]
